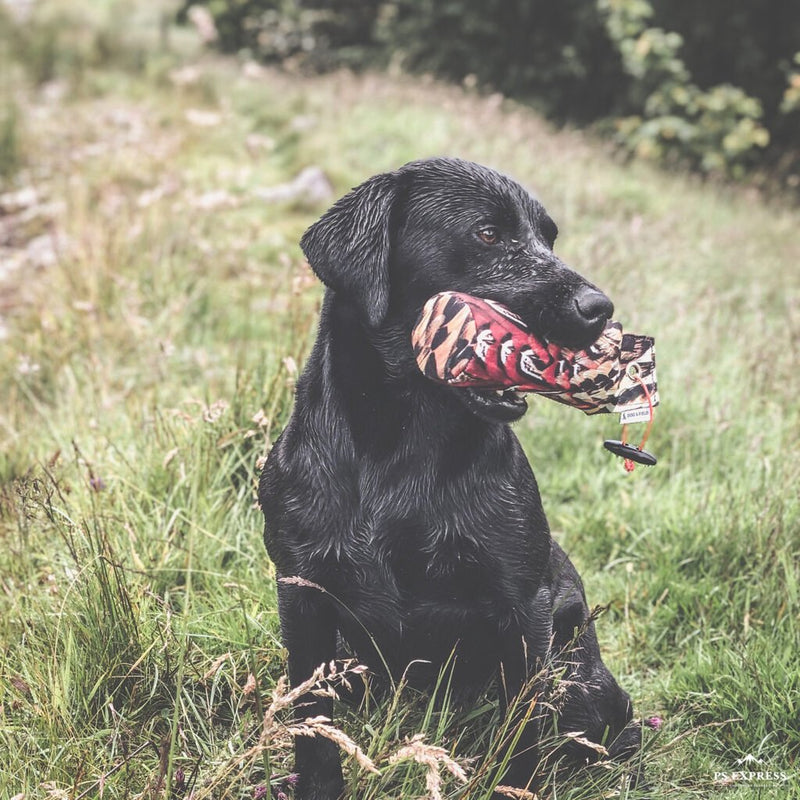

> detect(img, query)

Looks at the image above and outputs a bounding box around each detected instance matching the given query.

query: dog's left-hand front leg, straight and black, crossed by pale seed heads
[278,582,344,800]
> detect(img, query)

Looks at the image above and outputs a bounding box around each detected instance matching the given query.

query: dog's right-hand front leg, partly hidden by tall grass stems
[495,586,553,800]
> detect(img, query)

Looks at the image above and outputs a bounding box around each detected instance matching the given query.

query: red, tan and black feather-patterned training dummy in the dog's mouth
[412,292,658,414]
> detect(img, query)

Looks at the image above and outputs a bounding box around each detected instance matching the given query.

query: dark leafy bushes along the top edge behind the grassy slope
[178,0,800,180]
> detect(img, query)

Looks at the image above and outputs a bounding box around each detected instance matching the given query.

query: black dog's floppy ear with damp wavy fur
[300,173,397,327]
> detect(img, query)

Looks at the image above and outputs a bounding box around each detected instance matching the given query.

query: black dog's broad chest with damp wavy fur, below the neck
[273,406,547,629]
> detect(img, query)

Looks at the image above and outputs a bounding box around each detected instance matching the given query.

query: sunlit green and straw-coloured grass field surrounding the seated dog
[0,0,800,800]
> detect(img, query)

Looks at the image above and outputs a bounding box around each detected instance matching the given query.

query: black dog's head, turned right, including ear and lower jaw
[300,153,614,422]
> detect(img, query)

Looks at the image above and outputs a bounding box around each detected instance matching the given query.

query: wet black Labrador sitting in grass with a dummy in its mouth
[260,159,640,800]
